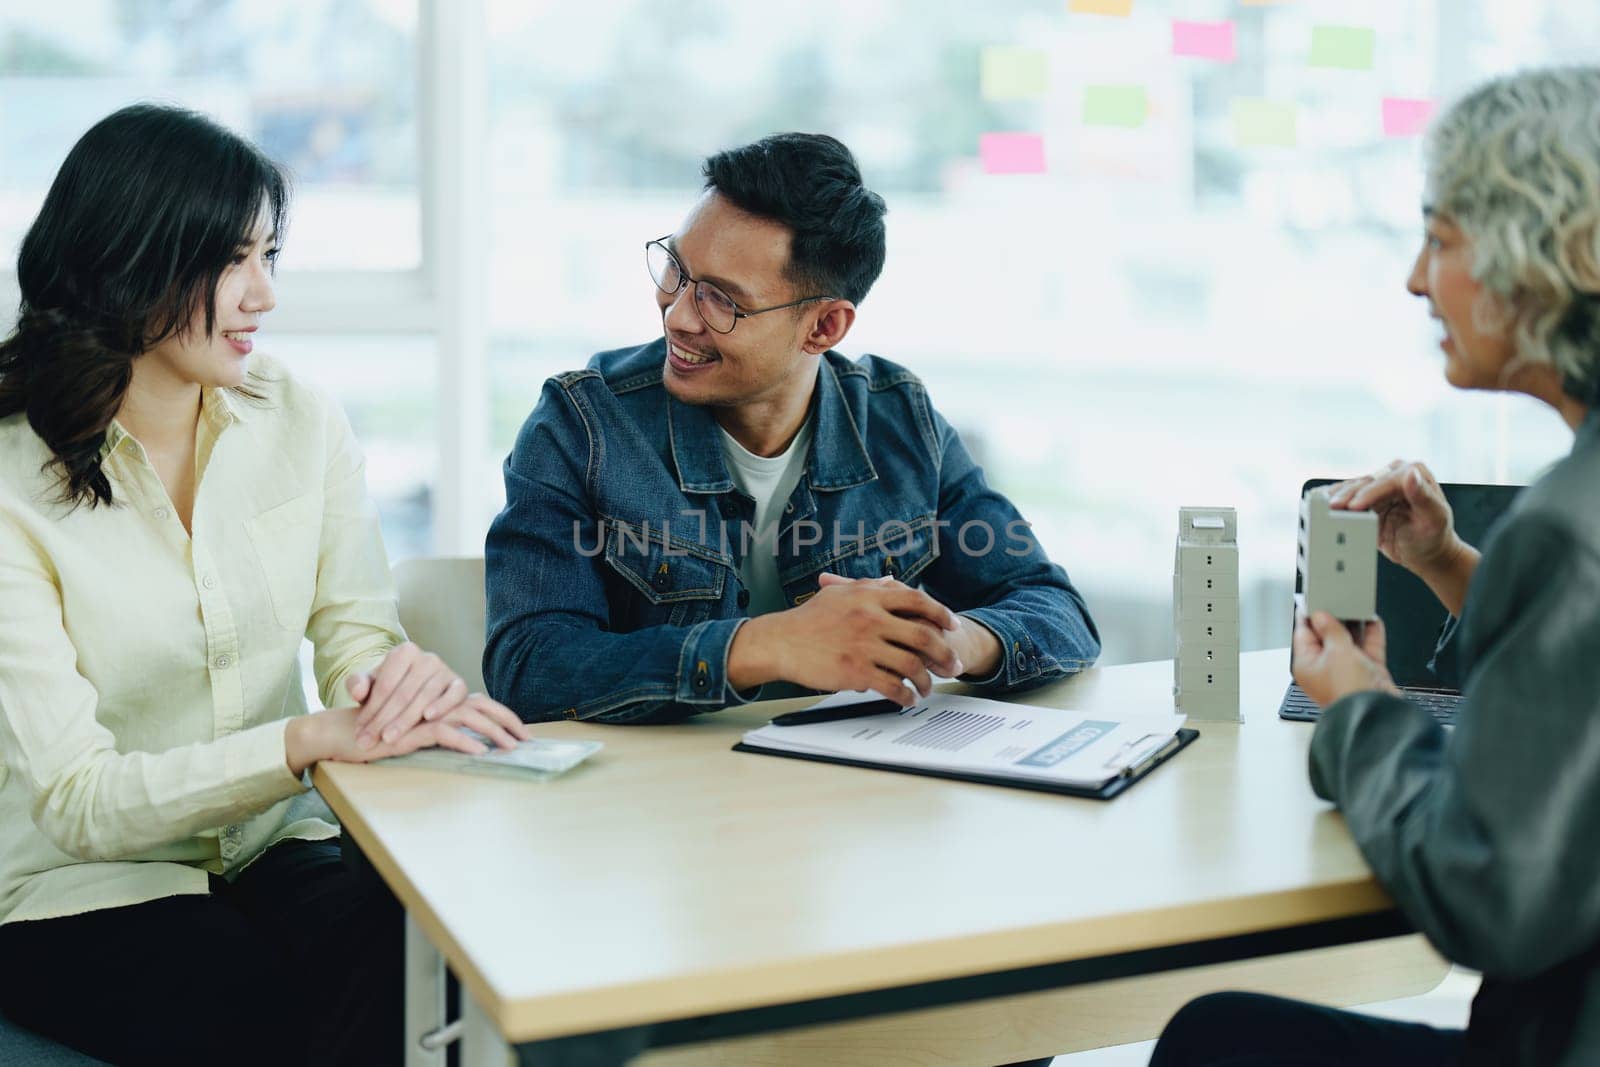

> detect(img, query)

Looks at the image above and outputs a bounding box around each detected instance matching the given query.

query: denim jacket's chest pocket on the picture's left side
[605,520,728,629]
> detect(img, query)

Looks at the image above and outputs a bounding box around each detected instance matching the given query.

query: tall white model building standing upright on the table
[1173,507,1242,721]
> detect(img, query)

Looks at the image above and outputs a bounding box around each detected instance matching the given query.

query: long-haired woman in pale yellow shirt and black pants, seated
[0,106,526,1064]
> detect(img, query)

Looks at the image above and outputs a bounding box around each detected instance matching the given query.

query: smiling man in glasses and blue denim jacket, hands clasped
[483,134,1099,723]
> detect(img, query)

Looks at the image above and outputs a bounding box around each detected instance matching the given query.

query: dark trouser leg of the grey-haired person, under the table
[1150,993,1466,1067]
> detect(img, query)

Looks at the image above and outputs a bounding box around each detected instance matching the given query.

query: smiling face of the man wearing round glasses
[656,192,829,406]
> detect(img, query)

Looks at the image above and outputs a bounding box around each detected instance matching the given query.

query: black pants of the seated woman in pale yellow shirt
[0,841,405,1067]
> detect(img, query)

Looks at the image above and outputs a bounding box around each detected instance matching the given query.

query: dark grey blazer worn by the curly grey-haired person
[1310,410,1600,1067]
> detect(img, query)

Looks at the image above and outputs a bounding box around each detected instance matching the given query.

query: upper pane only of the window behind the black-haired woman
[0,0,422,270]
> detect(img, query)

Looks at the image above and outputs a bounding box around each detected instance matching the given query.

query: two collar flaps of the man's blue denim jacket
[667,360,878,493]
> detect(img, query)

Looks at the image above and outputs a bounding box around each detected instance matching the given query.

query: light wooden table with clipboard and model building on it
[315,651,1446,1064]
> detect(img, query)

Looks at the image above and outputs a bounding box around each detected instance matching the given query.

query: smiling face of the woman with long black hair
[139,210,278,387]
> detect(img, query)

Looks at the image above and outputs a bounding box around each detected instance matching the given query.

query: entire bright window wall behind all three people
[0,0,1600,662]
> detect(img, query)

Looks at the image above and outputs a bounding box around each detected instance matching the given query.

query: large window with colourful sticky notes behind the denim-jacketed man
[488,0,1600,662]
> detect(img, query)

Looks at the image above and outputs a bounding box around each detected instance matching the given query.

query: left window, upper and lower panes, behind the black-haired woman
[0,0,437,553]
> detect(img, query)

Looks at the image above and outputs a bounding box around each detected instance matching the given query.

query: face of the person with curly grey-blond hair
[1406,211,1517,389]
